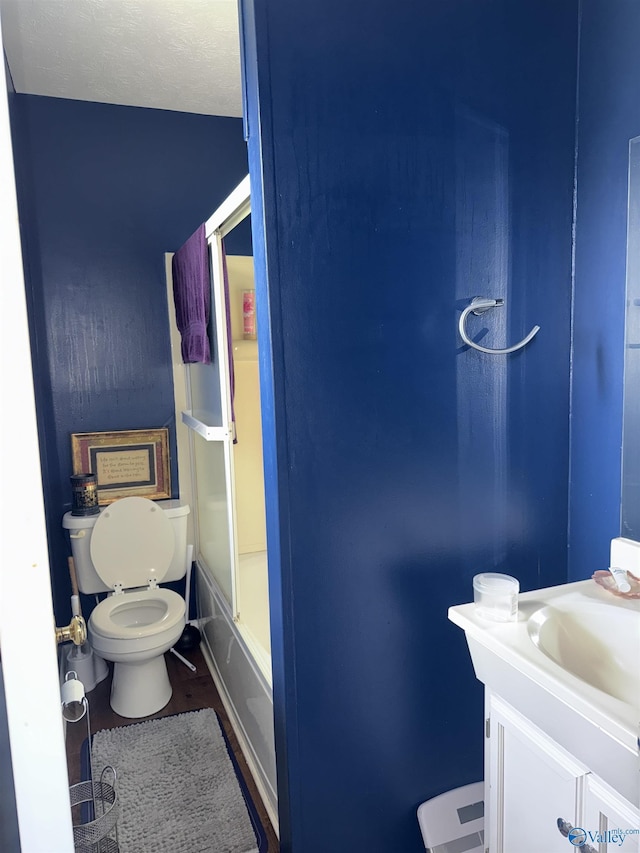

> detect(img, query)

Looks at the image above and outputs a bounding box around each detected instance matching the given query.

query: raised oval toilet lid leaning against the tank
[90,498,175,589]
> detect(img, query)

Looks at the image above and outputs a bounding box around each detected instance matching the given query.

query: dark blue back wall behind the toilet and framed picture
[11,95,247,624]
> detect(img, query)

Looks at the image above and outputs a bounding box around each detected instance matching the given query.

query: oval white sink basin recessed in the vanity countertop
[527,597,640,706]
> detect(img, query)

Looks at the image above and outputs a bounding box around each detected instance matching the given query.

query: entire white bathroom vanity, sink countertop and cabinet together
[449,580,640,853]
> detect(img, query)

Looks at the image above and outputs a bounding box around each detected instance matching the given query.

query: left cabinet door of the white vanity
[486,695,587,853]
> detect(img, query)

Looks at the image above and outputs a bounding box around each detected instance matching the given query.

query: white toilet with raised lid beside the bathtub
[62,497,189,718]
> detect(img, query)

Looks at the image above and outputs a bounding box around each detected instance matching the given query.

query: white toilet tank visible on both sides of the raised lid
[62,500,190,594]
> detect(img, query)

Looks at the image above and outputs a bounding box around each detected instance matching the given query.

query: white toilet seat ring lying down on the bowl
[89,589,185,640]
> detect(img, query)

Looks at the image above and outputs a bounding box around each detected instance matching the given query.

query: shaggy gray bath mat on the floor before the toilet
[92,708,258,853]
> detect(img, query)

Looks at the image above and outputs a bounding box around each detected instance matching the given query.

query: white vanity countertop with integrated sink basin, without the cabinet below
[449,580,640,802]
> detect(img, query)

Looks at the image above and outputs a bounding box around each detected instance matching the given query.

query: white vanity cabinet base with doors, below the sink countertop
[485,690,640,853]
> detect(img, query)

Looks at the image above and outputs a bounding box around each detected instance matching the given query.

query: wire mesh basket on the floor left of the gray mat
[69,765,120,853]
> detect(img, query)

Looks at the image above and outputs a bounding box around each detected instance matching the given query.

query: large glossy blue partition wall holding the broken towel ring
[244,0,578,853]
